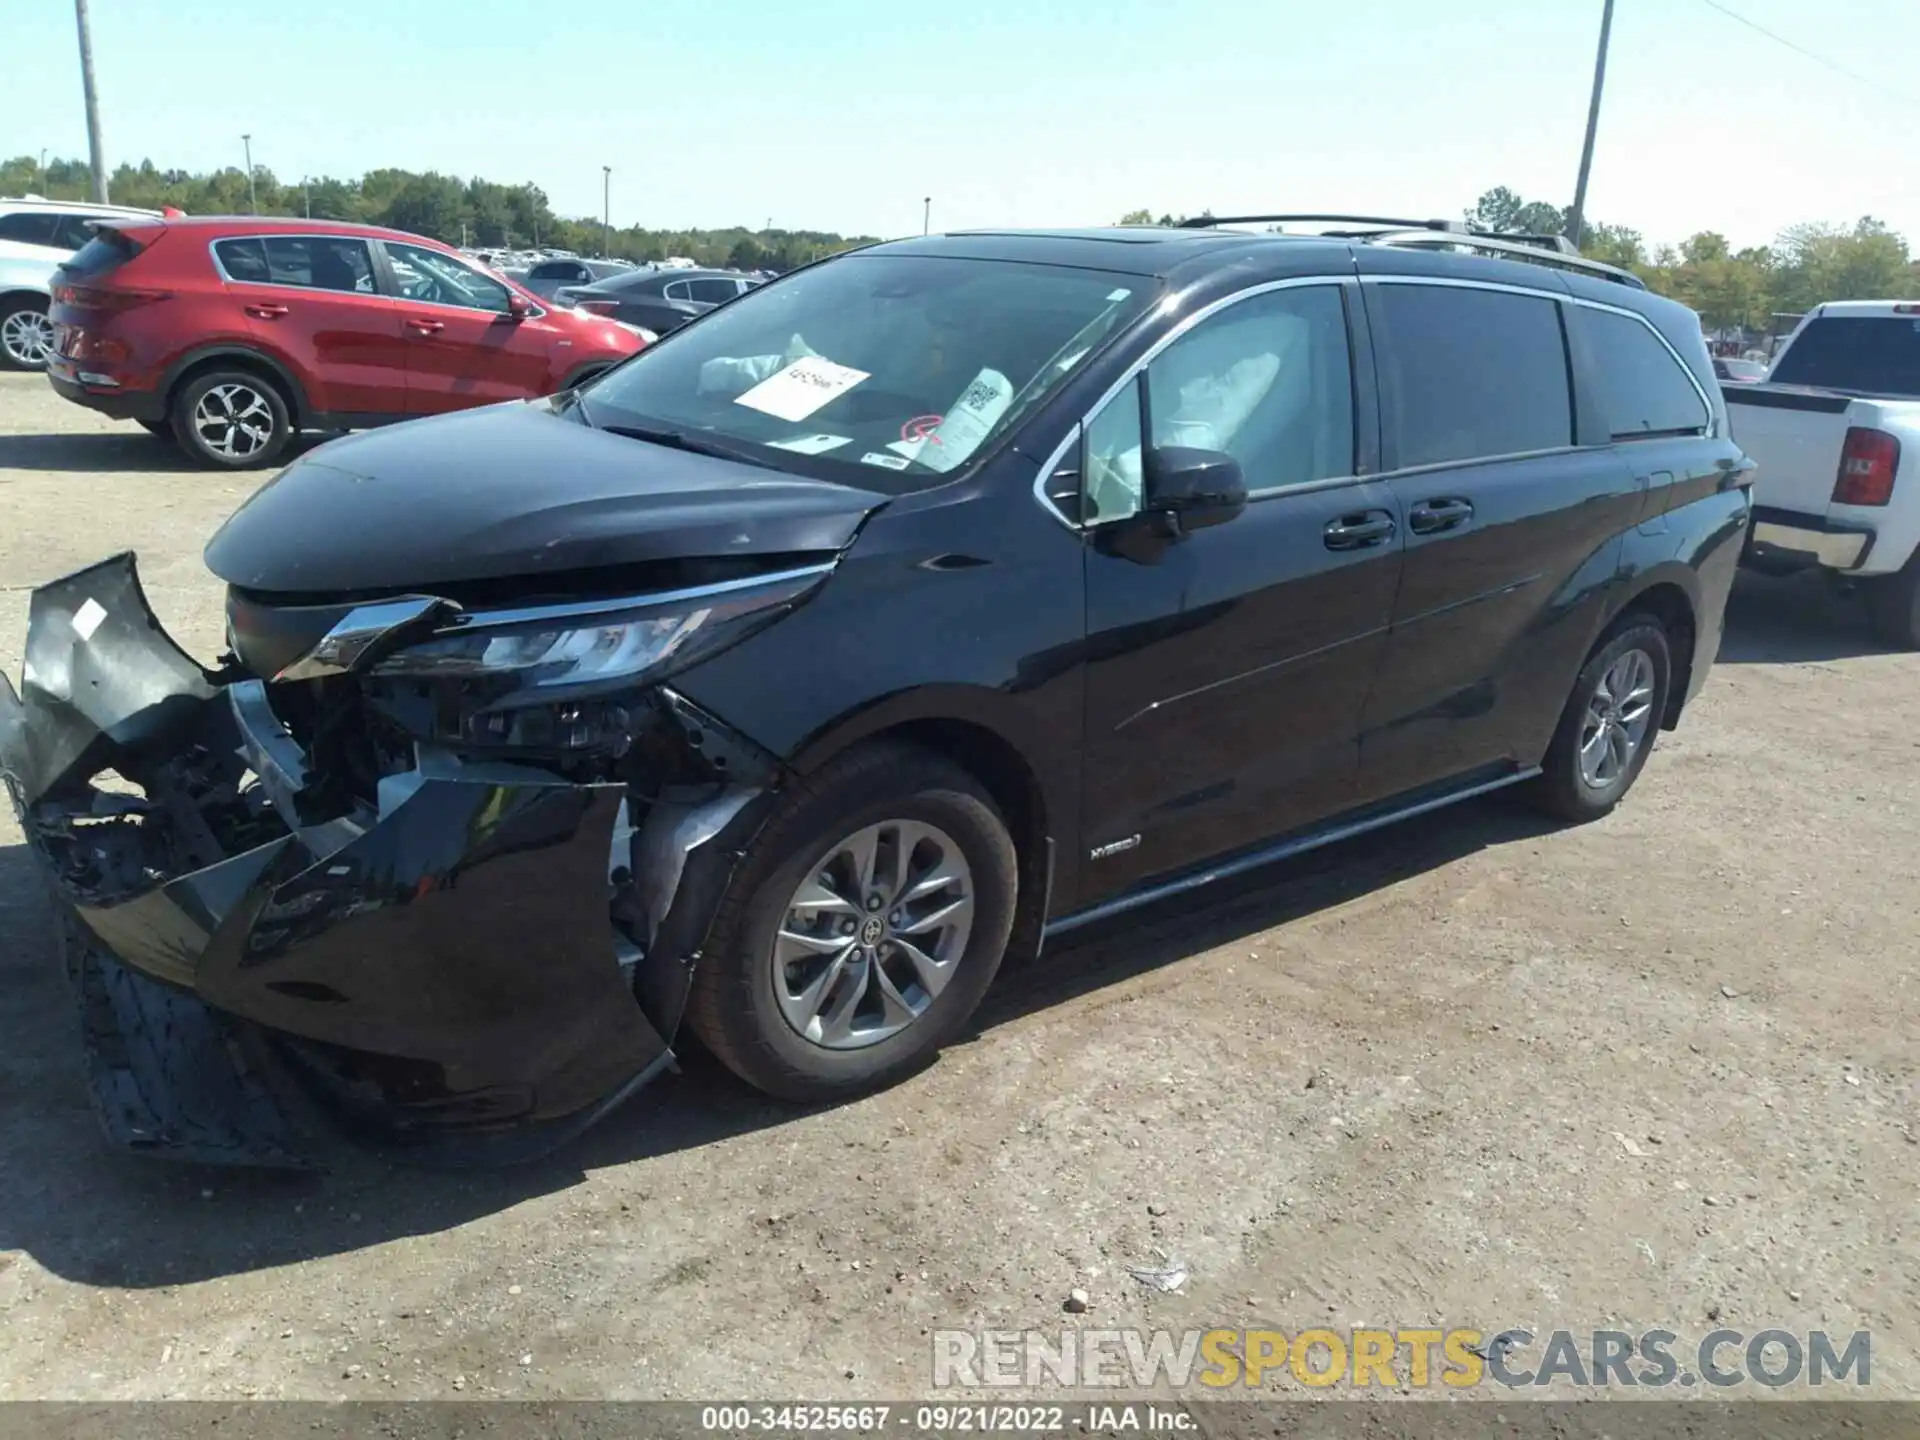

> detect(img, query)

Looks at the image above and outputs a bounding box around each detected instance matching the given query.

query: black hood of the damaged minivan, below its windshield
[205,401,887,595]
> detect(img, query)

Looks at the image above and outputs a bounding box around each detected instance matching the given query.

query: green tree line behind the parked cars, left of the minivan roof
[0,156,870,271]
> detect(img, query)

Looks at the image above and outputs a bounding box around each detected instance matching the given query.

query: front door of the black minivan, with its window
[1075,280,1400,900]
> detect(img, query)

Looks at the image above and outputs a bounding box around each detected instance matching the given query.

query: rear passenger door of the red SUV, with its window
[209,234,407,419]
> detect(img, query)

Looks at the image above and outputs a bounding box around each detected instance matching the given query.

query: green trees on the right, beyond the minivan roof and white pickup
[1119,186,1920,332]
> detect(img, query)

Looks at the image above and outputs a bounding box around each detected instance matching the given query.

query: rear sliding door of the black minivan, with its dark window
[1361,270,1644,799]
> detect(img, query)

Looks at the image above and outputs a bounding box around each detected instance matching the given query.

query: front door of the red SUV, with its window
[380,240,572,415]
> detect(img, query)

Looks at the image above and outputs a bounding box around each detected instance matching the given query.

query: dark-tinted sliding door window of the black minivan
[1367,284,1572,467]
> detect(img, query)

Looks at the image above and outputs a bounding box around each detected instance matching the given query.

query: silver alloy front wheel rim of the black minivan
[770,820,975,1050]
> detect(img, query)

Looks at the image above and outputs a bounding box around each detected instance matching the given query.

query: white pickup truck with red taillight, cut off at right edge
[1724,300,1920,649]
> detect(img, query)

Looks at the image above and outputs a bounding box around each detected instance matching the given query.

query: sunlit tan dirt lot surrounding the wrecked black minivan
[0,366,1920,1400]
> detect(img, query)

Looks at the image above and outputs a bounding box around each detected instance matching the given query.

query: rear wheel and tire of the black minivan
[1528,614,1672,824]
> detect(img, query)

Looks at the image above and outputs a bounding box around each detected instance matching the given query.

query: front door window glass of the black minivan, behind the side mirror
[1083,284,1354,522]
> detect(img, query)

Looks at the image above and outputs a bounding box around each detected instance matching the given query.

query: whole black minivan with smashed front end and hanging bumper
[0,225,1751,1164]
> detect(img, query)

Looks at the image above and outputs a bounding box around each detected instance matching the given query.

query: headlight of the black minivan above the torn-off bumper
[371,566,828,755]
